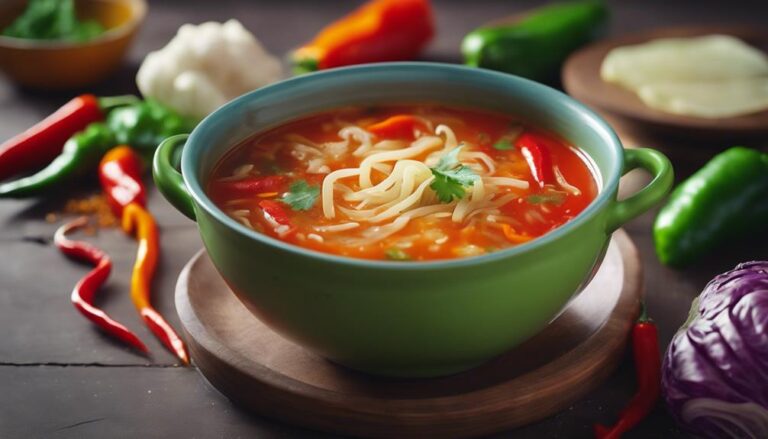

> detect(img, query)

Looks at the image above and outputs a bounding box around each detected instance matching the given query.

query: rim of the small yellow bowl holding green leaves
[0,0,148,50]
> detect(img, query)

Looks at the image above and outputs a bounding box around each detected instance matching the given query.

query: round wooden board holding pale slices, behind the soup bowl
[562,26,768,142]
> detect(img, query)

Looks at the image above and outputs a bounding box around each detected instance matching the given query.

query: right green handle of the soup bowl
[606,148,674,233]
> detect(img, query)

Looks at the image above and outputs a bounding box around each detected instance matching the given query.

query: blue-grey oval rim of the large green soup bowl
[181,62,623,271]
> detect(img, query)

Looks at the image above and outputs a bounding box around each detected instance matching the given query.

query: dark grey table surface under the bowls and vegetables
[0,0,768,438]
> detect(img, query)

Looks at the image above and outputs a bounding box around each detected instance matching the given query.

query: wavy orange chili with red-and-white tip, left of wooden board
[122,203,189,364]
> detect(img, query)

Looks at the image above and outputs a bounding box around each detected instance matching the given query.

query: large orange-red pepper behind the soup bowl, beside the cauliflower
[293,0,434,73]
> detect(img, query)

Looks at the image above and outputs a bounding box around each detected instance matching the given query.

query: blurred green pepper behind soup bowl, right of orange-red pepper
[461,0,608,81]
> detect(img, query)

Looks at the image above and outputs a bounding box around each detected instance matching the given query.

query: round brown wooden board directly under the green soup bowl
[176,231,642,438]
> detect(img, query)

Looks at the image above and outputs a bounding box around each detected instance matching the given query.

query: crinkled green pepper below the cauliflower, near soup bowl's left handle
[107,100,196,156]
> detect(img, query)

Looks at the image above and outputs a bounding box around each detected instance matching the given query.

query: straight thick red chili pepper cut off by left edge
[0,94,104,180]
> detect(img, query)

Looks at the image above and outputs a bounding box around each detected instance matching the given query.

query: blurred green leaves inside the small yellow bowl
[3,0,105,41]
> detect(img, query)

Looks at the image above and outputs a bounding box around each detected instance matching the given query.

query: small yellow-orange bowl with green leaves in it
[0,0,147,90]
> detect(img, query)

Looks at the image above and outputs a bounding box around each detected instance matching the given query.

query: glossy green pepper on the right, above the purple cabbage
[653,147,768,267]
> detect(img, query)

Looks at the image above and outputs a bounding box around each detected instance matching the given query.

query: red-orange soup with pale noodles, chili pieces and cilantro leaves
[207,105,597,261]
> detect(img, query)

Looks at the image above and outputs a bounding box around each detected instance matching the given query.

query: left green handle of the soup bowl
[152,134,195,221]
